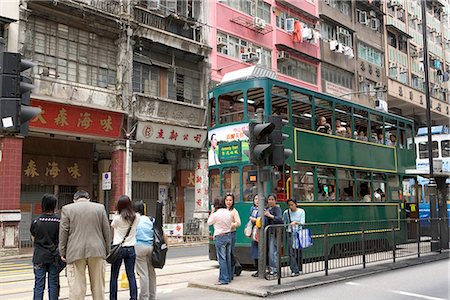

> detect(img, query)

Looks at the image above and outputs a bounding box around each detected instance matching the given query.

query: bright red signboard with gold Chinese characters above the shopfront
[30,99,123,138]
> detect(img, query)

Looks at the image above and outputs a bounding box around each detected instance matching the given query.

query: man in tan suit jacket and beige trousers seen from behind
[59,191,111,300]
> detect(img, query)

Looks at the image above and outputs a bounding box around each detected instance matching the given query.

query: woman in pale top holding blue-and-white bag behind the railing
[283,199,305,277]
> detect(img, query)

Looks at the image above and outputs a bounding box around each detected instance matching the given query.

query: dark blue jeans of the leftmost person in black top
[33,263,59,300]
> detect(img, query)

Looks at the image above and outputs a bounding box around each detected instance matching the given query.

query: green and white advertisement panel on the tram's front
[208,123,248,167]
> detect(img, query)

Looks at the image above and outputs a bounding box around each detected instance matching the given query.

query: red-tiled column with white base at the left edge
[0,136,23,256]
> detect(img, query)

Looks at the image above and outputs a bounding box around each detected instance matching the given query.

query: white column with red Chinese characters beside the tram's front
[194,150,209,235]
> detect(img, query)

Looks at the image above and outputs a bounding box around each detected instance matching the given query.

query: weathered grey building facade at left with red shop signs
[0,0,211,253]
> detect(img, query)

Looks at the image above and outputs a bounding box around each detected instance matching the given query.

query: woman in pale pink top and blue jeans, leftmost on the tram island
[208,198,234,285]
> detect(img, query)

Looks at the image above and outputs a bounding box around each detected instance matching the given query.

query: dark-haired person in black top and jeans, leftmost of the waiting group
[30,194,61,300]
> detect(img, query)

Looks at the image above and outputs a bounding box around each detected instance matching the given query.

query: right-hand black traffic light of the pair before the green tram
[269,115,292,166]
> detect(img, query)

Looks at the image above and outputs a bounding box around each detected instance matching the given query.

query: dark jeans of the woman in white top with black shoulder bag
[109,247,137,300]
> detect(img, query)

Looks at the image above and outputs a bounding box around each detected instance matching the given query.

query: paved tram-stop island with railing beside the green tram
[188,252,449,297]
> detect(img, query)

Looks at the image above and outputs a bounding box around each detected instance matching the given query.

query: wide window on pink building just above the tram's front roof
[217,32,272,68]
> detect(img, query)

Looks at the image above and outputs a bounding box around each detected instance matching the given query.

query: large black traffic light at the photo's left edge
[0,52,41,136]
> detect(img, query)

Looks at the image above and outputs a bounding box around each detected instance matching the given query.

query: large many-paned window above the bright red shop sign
[25,17,117,88]
